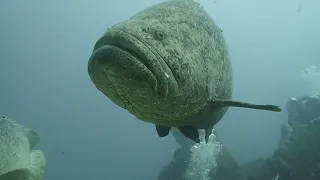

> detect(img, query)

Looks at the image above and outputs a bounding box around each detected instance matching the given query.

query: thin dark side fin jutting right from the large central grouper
[212,100,281,112]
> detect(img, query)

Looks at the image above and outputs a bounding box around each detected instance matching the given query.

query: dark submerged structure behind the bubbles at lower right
[158,94,320,180]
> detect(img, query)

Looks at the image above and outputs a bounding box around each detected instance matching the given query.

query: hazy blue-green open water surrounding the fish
[0,0,320,180]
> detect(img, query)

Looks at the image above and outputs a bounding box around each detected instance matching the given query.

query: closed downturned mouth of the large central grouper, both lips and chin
[88,28,176,120]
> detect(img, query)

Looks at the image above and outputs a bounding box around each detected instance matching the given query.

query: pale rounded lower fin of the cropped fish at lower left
[28,150,46,180]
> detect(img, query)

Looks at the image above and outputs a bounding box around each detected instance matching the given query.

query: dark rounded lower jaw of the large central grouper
[88,45,157,108]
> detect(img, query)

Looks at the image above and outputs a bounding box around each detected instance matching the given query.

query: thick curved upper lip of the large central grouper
[99,28,178,97]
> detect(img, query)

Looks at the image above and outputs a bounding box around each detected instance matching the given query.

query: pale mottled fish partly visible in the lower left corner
[0,116,46,180]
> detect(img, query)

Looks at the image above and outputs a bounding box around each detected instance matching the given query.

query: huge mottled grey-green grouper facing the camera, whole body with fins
[88,0,281,142]
